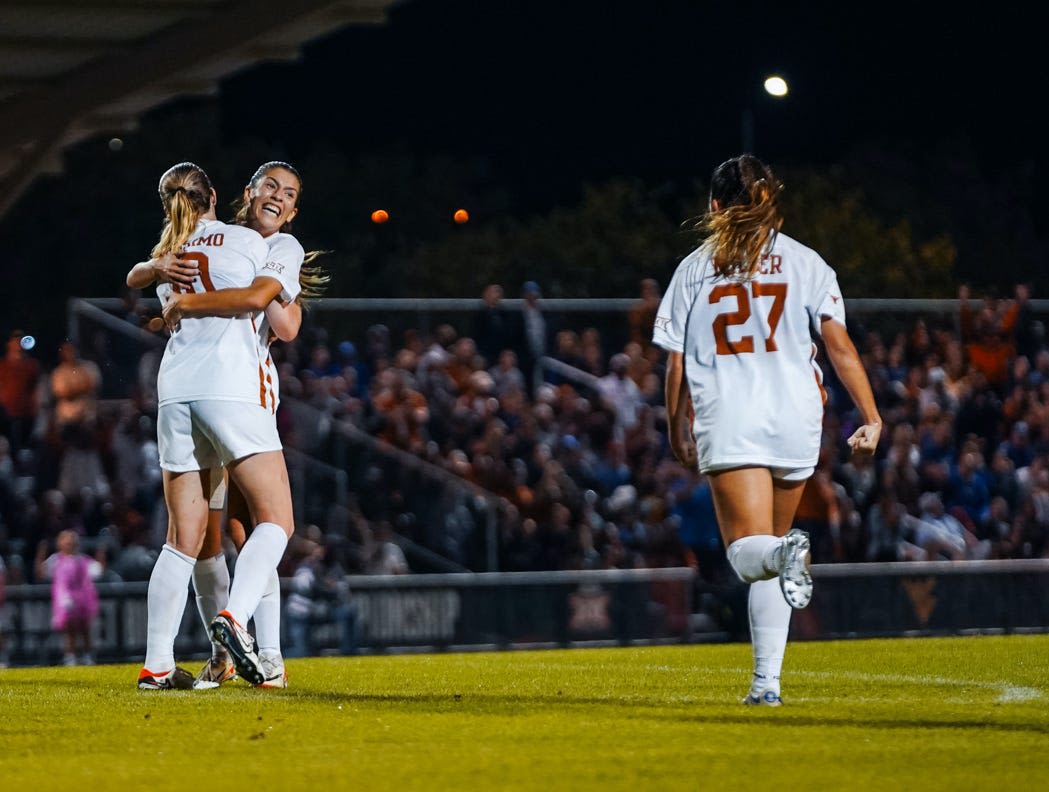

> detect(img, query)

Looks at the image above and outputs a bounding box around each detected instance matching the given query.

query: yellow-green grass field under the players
[0,636,1049,792]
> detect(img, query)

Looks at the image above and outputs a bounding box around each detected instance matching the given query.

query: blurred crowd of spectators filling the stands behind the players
[0,280,1049,604]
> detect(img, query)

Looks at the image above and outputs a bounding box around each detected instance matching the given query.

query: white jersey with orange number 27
[652,234,845,471]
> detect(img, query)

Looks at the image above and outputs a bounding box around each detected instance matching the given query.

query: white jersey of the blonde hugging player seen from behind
[156,220,272,406]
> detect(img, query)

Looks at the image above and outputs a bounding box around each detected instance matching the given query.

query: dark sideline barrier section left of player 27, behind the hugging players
[0,568,695,665]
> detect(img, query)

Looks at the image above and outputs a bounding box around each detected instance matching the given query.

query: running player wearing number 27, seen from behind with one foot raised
[652,154,881,706]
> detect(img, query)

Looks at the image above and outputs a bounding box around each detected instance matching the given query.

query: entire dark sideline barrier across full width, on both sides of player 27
[4,559,1049,665]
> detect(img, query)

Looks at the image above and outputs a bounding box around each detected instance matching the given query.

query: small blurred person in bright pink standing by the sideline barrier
[37,530,102,665]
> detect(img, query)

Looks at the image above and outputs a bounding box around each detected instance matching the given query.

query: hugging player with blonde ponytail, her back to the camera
[128,163,298,689]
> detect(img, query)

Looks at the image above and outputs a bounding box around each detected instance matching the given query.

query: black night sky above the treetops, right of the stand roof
[221,0,1046,202]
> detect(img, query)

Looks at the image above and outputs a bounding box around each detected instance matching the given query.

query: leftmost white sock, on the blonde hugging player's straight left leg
[145,544,196,673]
